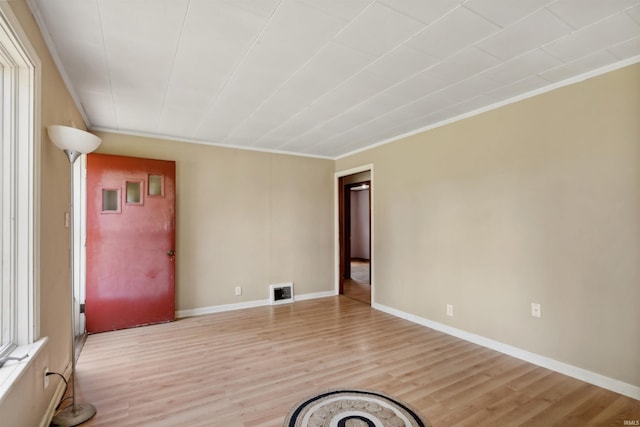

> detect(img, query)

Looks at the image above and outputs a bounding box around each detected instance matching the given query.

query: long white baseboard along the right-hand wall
[372,303,640,400]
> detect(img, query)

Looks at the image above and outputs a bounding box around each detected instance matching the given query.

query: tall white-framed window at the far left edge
[0,2,37,362]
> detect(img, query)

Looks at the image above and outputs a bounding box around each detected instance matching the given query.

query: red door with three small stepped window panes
[85,154,175,333]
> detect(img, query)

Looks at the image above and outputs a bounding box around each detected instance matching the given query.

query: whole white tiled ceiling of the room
[29,0,640,158]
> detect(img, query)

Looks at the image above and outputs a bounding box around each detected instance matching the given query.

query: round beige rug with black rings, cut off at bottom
[284,390,430,427]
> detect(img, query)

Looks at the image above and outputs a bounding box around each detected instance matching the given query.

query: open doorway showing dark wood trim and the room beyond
[336,166,373,304]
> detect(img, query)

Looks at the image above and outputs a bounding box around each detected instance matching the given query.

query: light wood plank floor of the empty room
[67,296,640,427]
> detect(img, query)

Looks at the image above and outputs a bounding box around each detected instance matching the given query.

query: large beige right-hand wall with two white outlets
[336,64,640,386]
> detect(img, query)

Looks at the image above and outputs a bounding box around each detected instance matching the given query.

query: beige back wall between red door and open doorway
[97,132,334,311]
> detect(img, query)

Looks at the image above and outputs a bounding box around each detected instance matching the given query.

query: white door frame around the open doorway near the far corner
[333,163,376,307]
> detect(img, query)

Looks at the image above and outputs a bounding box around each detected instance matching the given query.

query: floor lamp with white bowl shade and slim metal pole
[47,125,102,427]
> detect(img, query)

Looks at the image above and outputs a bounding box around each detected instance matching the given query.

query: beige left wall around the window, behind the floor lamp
[0,0,83,426]
